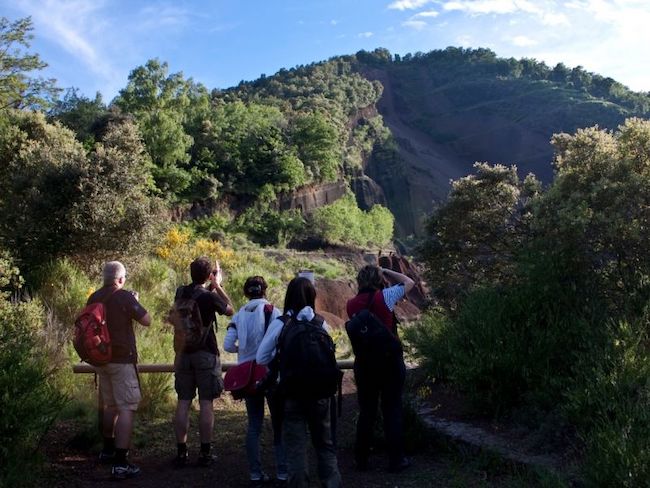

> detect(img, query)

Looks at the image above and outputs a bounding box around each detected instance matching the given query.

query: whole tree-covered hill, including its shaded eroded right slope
[51,48,650,238]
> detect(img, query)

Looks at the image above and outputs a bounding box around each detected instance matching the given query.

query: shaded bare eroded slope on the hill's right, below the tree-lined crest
[362,63,623,237]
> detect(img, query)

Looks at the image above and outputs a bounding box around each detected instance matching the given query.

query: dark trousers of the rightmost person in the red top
[354,358,406,466]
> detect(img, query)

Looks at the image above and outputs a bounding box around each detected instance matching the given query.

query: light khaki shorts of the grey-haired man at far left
[95,363,142,412]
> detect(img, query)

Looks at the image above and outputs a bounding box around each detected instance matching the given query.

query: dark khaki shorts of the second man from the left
[174,351,223,400]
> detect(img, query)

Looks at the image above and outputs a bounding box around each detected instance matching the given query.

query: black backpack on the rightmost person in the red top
[345,293,402,368]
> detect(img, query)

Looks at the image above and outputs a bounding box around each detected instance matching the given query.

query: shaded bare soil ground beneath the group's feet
[40,372,532,488]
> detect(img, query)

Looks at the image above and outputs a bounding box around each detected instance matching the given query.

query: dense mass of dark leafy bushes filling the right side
[415,119,650,480]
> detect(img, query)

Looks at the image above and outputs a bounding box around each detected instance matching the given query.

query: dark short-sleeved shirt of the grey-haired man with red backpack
[87,286,147,363]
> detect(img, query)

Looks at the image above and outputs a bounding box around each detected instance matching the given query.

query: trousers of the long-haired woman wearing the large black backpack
[282,398,342,488]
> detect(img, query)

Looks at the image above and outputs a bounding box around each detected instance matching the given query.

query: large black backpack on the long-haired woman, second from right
[277,315,343,400]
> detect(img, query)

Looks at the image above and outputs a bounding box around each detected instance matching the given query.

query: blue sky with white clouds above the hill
[5,0,650,100]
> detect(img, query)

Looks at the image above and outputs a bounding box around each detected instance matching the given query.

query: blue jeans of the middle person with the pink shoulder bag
[245,395,287,480]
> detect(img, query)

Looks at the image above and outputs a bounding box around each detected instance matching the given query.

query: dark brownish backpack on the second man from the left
[167,287,210,353]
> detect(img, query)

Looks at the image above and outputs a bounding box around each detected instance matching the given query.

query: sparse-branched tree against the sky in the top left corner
[0,17,60,110]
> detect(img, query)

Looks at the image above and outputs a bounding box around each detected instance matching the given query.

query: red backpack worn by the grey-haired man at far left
[72,290,117,366]
